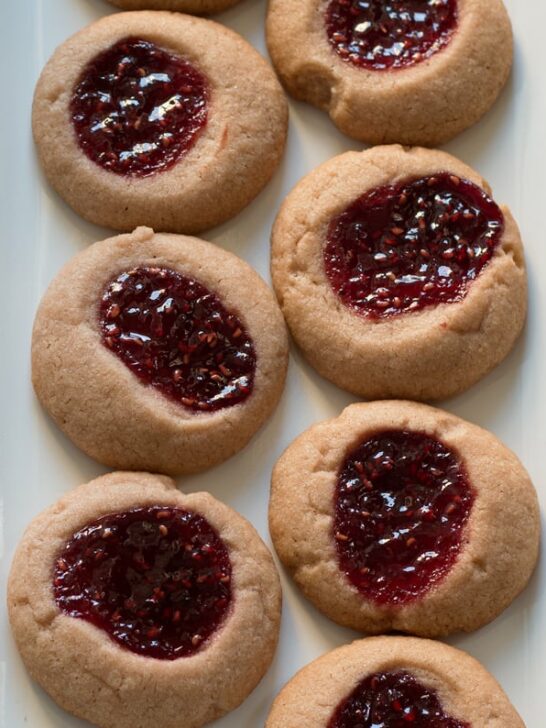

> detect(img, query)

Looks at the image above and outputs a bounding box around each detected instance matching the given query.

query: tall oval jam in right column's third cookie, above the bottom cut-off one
[334,430,474,605]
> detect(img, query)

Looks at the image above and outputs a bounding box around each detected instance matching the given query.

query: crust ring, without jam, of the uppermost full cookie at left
[32,11,288,233]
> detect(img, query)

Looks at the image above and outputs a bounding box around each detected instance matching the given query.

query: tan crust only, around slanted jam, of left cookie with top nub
[32,228,288,474]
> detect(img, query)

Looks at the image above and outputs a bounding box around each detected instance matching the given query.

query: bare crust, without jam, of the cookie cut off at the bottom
[266,637,525,728]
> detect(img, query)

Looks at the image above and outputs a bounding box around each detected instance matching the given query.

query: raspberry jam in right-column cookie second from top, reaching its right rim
[324,173,504,319]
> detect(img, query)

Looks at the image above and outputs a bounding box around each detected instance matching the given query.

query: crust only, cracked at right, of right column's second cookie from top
[271,145,527,400]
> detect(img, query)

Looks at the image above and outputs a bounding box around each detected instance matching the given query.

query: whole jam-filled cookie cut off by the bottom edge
[266,637,524,728]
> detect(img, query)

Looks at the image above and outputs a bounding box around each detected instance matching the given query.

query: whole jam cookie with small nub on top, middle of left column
[32,228,288,474]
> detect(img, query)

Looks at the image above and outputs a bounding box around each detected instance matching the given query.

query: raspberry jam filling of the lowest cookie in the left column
[53,506,231,660]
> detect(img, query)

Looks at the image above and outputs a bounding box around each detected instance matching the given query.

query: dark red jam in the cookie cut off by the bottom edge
[328,672,470,728]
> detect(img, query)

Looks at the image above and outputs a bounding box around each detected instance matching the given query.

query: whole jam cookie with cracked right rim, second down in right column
[271,145,527,400]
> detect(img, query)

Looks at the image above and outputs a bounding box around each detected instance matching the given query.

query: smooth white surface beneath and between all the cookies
[0,0,546,728]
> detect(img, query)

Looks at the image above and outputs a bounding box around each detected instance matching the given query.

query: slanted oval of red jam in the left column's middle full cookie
[100,268,256,412]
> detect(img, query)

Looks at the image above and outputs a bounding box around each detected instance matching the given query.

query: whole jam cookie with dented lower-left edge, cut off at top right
[267,0,513,146]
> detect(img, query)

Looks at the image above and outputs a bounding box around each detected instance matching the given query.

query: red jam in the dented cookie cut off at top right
[326,0,457,71]
